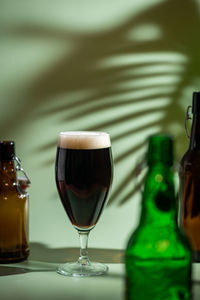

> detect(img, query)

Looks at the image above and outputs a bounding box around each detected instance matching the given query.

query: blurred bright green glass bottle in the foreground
[126,135,191,300]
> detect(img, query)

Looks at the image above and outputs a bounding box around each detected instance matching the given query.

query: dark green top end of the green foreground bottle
[147,134,173,166]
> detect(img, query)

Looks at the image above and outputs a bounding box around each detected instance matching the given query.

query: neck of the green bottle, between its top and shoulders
[140,162,177,226]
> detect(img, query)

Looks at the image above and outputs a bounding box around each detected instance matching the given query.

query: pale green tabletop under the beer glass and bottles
[0,250,200,300]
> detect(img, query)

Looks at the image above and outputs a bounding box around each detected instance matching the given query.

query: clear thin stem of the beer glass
[78,231,90,266]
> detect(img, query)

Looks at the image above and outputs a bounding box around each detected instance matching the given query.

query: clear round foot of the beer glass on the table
[57,262,108,277]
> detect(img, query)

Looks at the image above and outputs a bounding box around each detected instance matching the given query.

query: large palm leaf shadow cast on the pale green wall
[2,0,200,204]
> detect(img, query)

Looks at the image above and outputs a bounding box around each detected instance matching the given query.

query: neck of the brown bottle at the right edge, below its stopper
[189,113,200,150]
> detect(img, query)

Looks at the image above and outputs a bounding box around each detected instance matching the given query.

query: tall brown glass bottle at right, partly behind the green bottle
[179,92,200,262]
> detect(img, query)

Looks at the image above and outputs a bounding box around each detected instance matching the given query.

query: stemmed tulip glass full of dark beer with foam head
[56,131,113,276]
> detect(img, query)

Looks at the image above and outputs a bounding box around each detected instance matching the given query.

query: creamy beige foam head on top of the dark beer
[58,131,111,149]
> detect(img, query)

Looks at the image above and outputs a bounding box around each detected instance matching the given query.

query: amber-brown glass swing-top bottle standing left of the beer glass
[0,141,29,263]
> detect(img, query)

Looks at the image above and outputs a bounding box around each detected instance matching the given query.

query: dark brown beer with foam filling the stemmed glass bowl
[56,132,112,230]
